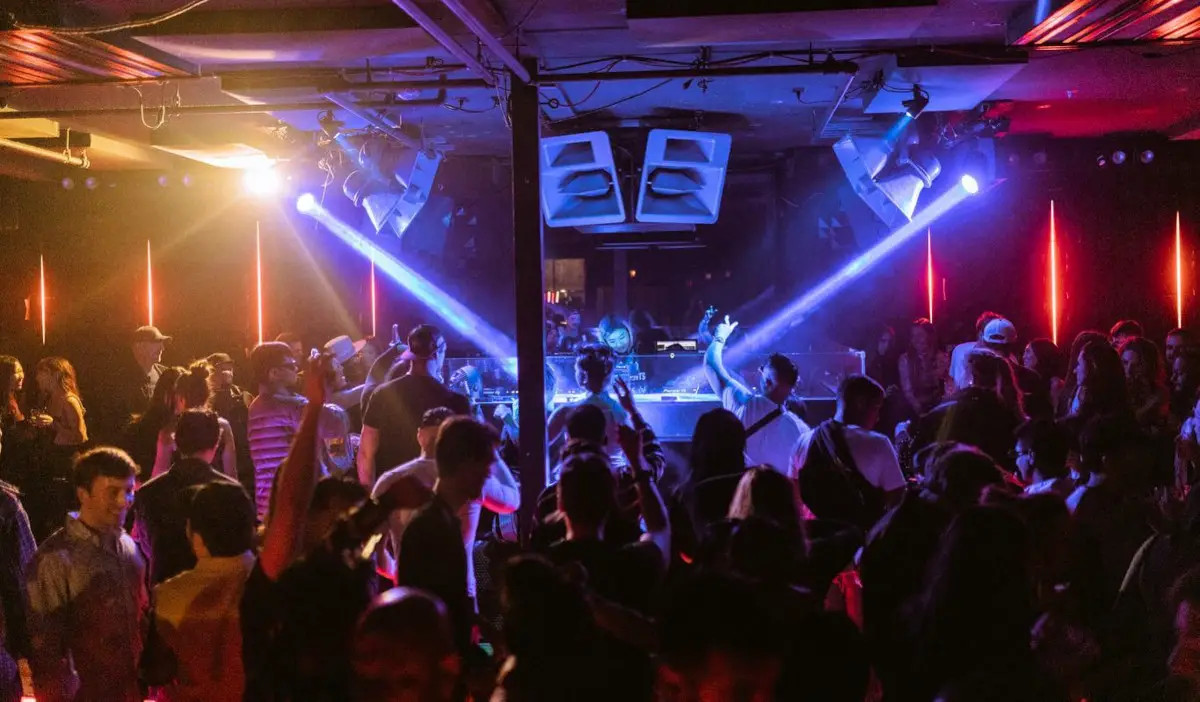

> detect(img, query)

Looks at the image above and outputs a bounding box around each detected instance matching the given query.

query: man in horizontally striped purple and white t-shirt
[247,341,344,520]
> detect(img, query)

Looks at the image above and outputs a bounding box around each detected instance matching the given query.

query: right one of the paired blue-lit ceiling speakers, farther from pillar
[637,130,733,224]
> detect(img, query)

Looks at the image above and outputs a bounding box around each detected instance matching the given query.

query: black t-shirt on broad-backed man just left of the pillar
[362,374,470,475]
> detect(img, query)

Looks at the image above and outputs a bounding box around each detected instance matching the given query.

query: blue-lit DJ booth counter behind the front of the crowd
[446,350,865,442]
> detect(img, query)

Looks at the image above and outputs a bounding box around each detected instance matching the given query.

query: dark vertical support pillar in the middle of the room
[509,61,546,540]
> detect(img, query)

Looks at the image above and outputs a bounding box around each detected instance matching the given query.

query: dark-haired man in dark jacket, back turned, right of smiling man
[133,408,236,584]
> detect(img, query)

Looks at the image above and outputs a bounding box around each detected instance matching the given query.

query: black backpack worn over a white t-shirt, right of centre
[798,419,883,532]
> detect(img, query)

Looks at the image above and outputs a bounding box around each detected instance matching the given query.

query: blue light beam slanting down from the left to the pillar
[297,200,517,367]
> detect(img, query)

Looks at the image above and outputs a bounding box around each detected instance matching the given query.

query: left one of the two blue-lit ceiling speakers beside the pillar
[540,132,625,227]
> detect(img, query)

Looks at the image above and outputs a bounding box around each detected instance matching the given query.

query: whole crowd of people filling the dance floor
[0,312,1200,702]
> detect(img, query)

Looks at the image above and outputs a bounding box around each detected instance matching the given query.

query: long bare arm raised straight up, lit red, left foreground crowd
[259,355,329,580]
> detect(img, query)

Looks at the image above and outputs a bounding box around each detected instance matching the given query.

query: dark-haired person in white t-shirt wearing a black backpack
[794,376,905,532]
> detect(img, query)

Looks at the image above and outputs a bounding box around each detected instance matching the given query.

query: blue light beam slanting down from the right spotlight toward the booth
[676,182,978,388]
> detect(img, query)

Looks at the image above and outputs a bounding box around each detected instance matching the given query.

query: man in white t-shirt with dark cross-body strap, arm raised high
[704,316,809,479]
